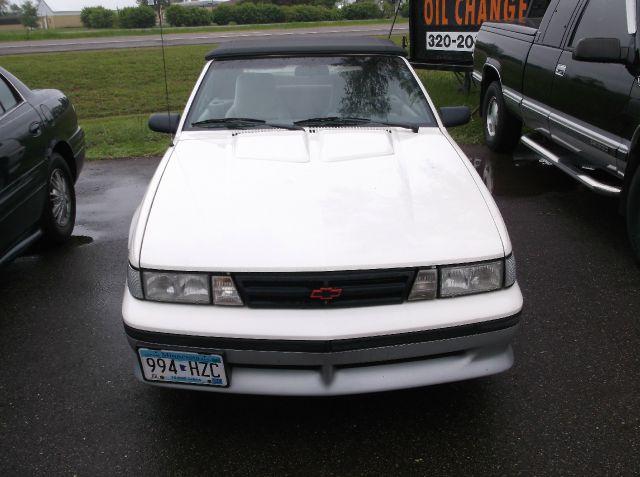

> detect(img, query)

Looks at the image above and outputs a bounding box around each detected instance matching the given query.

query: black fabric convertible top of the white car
[205,36,407,60]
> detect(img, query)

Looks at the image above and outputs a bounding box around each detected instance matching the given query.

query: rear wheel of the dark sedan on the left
[42,153,76,243]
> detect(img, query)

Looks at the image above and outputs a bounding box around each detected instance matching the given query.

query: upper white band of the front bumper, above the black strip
[122,283,522,340]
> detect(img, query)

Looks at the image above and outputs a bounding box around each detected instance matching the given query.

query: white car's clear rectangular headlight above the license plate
[142,272,211,304]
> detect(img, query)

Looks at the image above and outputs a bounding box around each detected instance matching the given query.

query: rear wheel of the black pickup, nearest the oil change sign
[482,81,522,152]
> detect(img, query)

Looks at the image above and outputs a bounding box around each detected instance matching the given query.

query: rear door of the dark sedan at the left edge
[0,75,46,256]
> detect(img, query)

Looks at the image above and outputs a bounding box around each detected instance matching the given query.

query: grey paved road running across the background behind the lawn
[0,24,409,55]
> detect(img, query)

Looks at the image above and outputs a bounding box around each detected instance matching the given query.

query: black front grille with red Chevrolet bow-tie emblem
[234,268,416,308]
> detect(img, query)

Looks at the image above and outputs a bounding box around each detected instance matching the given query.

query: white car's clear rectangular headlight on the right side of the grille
[440,260,504,297]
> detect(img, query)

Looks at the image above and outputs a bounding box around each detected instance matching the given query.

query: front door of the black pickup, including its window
[549,0,636,172]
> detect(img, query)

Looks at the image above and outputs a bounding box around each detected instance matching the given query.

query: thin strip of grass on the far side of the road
[0,18,408,42]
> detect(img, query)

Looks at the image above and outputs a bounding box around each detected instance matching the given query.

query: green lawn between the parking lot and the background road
[2,41,482,159]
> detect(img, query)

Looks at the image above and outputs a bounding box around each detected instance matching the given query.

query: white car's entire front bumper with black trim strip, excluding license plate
[123,284,522,396]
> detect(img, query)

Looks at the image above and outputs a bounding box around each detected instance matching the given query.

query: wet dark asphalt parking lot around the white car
[0,147,640,476]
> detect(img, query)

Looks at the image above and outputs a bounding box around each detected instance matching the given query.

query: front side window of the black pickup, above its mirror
[570,0,629,47]
